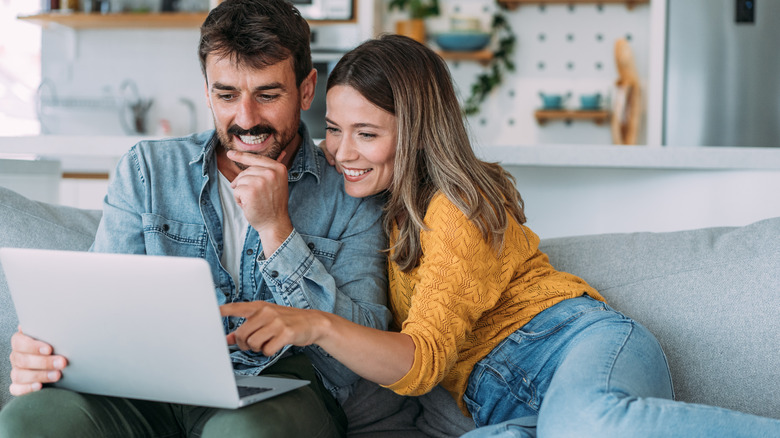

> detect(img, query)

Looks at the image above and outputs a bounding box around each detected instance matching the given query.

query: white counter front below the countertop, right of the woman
[506,165,780,238]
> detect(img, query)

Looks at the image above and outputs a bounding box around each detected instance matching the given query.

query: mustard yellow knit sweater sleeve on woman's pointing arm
[387,195,506,395]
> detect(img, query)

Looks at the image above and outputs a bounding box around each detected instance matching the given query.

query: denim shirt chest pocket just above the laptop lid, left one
[141,213,208,258]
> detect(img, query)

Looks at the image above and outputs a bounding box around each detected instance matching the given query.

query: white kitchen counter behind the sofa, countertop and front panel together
[0,136,780,237]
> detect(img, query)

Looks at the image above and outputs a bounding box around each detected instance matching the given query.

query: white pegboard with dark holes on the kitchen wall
[414,0,650,146]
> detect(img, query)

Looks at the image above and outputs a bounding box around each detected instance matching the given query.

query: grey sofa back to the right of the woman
[542,218,780,418]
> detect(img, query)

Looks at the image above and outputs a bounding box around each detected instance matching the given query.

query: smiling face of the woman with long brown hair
[325,85,397,198]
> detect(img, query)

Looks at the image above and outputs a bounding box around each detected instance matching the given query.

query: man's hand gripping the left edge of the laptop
[9,329,68,396]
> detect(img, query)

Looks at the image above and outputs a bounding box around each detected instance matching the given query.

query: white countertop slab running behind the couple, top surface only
[0,136,780,172]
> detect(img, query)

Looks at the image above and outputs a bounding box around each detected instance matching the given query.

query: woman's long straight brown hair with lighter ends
[327,35,525,272]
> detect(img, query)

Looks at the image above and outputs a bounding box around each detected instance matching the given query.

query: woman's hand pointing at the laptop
[220,301,327,356]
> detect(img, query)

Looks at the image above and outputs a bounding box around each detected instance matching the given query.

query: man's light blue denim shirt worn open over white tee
[91,123,390,402]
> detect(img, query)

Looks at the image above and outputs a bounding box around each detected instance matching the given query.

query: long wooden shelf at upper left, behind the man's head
[19,12,355,29]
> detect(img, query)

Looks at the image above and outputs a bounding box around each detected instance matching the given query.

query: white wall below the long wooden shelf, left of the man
[41,27,211,135]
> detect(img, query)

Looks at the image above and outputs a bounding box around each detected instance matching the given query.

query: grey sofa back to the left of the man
[0,187,101,407]
